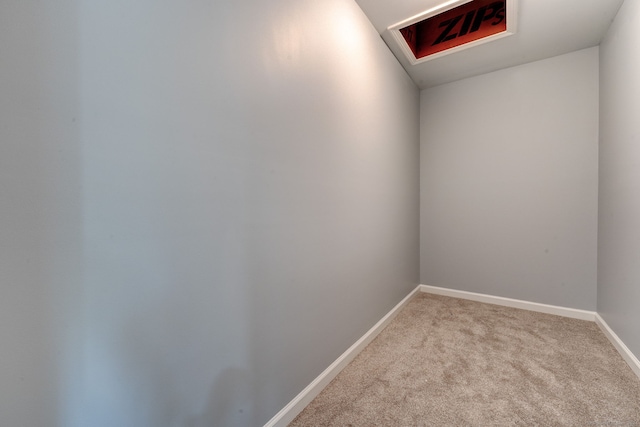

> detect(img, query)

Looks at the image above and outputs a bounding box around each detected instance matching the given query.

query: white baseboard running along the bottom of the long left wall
[264,286,420,427]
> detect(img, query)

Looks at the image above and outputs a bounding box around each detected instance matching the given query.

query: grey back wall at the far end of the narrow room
[420,47,598,310]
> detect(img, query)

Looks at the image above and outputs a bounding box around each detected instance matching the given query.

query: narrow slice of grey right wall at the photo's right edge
[598,0,640,357]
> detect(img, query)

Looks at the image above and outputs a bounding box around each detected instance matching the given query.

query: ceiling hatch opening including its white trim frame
[389,0,515,64]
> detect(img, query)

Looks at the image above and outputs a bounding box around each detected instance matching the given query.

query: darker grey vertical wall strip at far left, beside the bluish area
[0,0,81,427]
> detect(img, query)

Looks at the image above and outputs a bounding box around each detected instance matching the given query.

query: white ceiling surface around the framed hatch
[356,0,623,89]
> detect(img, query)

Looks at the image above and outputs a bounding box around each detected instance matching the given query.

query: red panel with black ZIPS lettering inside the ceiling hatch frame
[400,0,507,59]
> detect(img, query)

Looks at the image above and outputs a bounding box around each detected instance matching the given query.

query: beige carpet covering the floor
[290,293,640,427]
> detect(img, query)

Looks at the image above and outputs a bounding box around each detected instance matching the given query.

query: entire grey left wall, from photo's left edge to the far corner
[0,0,419,427]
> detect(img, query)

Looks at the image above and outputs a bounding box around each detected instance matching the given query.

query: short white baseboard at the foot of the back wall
[419,285,596,322]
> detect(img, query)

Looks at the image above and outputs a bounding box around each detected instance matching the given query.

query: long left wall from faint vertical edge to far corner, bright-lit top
[76,0,419,427]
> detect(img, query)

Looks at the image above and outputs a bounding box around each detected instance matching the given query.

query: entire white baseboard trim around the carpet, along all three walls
[264,285,640,427]
